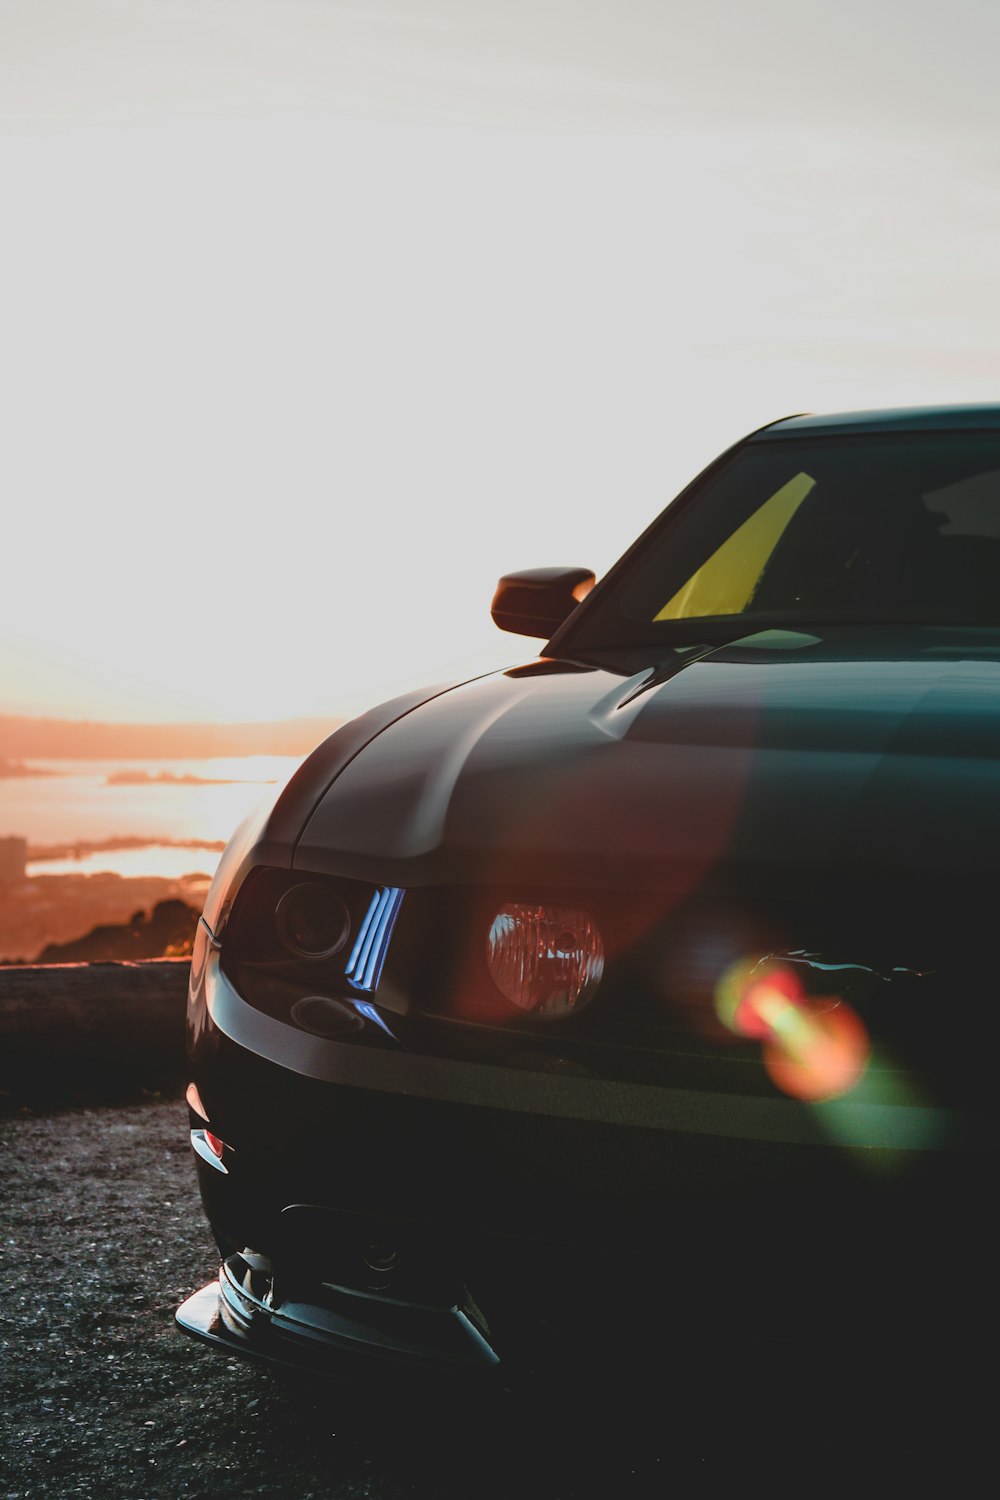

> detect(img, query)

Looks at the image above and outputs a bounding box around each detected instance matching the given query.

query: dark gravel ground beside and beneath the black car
[0,1100,997,1500]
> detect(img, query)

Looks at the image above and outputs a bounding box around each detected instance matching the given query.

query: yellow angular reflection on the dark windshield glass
[652,474,816,620]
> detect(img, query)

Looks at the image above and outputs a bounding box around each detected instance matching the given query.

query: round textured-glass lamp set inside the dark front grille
[487,903,604,1020]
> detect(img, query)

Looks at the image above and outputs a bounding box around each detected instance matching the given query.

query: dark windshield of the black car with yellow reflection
[567,432,1000,647]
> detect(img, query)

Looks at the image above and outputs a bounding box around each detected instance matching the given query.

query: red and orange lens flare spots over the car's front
[715,957,871,1101]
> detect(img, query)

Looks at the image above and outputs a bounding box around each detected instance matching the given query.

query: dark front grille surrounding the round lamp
[387,881,997,1107]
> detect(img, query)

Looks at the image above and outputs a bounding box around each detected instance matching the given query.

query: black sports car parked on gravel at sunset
[177,407,1000,1386]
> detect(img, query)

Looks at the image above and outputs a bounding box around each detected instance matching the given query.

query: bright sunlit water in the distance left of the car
[0,756,301,879]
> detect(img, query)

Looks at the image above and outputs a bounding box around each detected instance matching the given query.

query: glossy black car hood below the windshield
[294,630,1000,893]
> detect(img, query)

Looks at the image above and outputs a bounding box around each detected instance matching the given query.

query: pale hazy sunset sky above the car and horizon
[0,0,1000,723]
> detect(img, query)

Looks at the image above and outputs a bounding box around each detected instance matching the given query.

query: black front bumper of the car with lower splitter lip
[177,951,985,1388]
